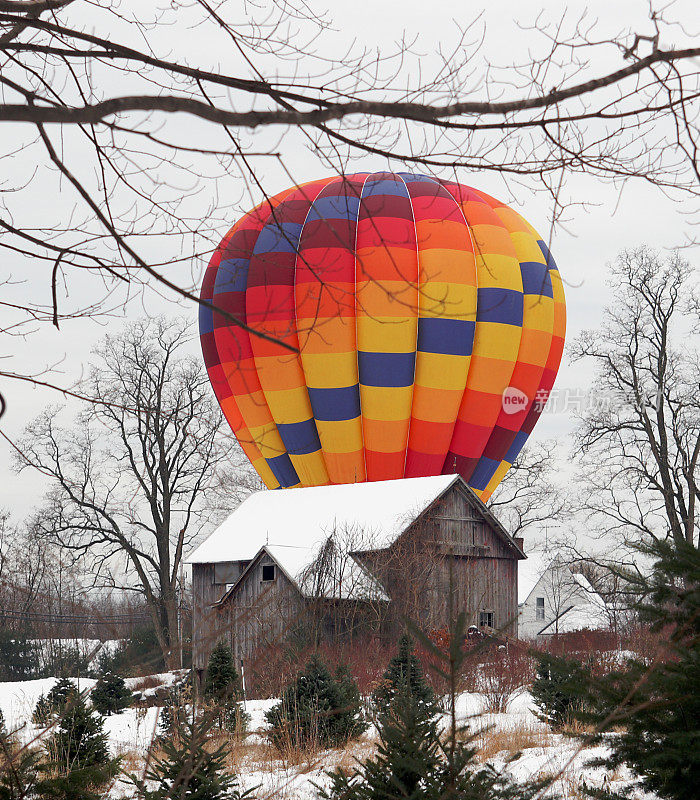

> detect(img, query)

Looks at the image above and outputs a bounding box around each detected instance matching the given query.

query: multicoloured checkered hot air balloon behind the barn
[200,172,566,500]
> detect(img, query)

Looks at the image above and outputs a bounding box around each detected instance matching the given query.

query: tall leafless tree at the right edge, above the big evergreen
[574,247,700,546]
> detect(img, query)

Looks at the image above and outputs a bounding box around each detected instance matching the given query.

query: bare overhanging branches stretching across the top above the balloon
[0,0,700,412]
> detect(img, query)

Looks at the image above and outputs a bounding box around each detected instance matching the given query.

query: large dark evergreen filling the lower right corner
[579,541,700,800]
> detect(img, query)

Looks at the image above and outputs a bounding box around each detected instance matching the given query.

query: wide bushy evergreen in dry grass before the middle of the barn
[265,656,366,747]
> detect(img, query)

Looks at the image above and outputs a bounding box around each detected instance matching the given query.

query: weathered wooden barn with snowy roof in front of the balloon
[188,475,525,678]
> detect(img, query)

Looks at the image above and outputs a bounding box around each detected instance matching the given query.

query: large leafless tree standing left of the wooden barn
[19,319,230,666]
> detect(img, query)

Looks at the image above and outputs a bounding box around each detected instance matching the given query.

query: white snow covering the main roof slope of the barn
[187,475,461,571]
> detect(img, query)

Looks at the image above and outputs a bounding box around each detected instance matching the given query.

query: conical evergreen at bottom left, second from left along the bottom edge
[38,694,119,800]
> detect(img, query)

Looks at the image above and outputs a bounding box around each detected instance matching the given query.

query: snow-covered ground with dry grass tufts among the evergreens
[0,674,651,800]
